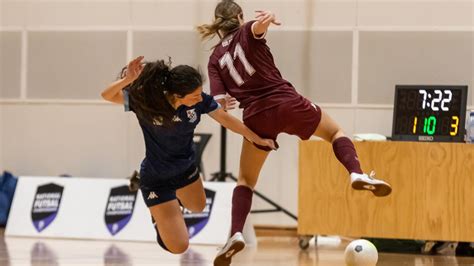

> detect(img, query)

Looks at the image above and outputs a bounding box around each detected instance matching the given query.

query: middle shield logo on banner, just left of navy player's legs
[105,185,137,235]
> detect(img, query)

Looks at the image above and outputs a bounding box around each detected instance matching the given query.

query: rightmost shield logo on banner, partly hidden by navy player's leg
[183,188,216,239]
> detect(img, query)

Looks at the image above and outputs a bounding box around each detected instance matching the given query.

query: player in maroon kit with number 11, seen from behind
[198,0,392,265]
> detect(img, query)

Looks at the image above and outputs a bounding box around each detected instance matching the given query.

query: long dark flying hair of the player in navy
[121,60,202,127]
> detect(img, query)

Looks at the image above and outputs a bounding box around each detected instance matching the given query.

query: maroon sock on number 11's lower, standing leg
[230,186,253,236]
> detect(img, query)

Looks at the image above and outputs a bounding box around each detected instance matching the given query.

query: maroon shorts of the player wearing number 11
[244,96,321,150]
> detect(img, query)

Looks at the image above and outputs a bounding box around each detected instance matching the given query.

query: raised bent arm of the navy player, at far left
[101,56,143,104]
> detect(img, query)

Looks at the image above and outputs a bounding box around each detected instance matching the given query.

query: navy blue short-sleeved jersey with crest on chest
[123,90,220,185]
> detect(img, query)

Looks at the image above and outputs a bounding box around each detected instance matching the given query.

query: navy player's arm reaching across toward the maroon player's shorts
[209,108,276,150]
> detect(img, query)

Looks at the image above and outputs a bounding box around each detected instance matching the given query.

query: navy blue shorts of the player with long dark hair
[140,165,199,207]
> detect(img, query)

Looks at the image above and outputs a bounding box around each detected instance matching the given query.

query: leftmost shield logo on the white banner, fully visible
[31,183,64,232]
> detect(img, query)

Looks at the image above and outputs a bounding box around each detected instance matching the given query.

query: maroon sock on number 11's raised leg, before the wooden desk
[332,137,362,174]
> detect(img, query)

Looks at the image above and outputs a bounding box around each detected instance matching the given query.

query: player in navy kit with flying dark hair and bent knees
[102,57,275,254]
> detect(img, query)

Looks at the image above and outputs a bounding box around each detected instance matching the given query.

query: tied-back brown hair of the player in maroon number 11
[197,0,243,40]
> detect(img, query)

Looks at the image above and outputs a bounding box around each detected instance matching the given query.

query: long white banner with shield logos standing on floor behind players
[5,177,235,245]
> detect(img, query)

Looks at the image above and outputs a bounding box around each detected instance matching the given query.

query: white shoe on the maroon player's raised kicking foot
[351,171,392,197]
